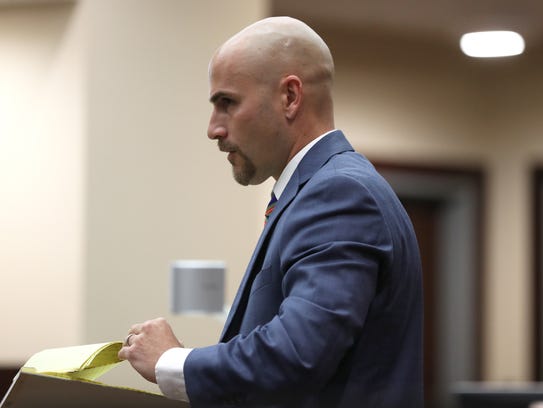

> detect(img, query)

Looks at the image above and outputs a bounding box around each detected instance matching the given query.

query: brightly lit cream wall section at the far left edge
[0,5,85,365]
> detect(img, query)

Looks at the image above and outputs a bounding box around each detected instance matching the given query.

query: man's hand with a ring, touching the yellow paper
[119,317,183,383]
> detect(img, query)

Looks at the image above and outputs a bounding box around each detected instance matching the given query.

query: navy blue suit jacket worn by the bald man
[184,131,423,408]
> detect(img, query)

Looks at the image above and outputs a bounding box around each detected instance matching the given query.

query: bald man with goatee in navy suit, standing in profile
[119,17,422,408]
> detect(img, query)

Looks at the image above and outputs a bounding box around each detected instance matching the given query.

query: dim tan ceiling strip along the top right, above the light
[272,0,543,46]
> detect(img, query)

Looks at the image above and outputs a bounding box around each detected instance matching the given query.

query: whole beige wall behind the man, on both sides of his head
[0,0,543,388]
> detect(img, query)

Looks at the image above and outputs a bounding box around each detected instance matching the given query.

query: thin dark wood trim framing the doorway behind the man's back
[371,159,486,381]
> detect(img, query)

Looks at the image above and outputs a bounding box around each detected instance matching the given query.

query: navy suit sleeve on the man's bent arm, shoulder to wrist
[185,172,391,408]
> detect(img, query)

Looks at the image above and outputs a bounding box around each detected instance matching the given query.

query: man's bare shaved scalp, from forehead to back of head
[210,17,334,131]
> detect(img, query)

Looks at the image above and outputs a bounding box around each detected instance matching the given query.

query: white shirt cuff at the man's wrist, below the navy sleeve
[155,347,192,402]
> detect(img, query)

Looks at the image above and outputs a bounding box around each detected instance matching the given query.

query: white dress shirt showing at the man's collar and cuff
[155,130,333,402]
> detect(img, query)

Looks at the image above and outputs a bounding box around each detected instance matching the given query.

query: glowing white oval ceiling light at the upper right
[460,31,524,58]
